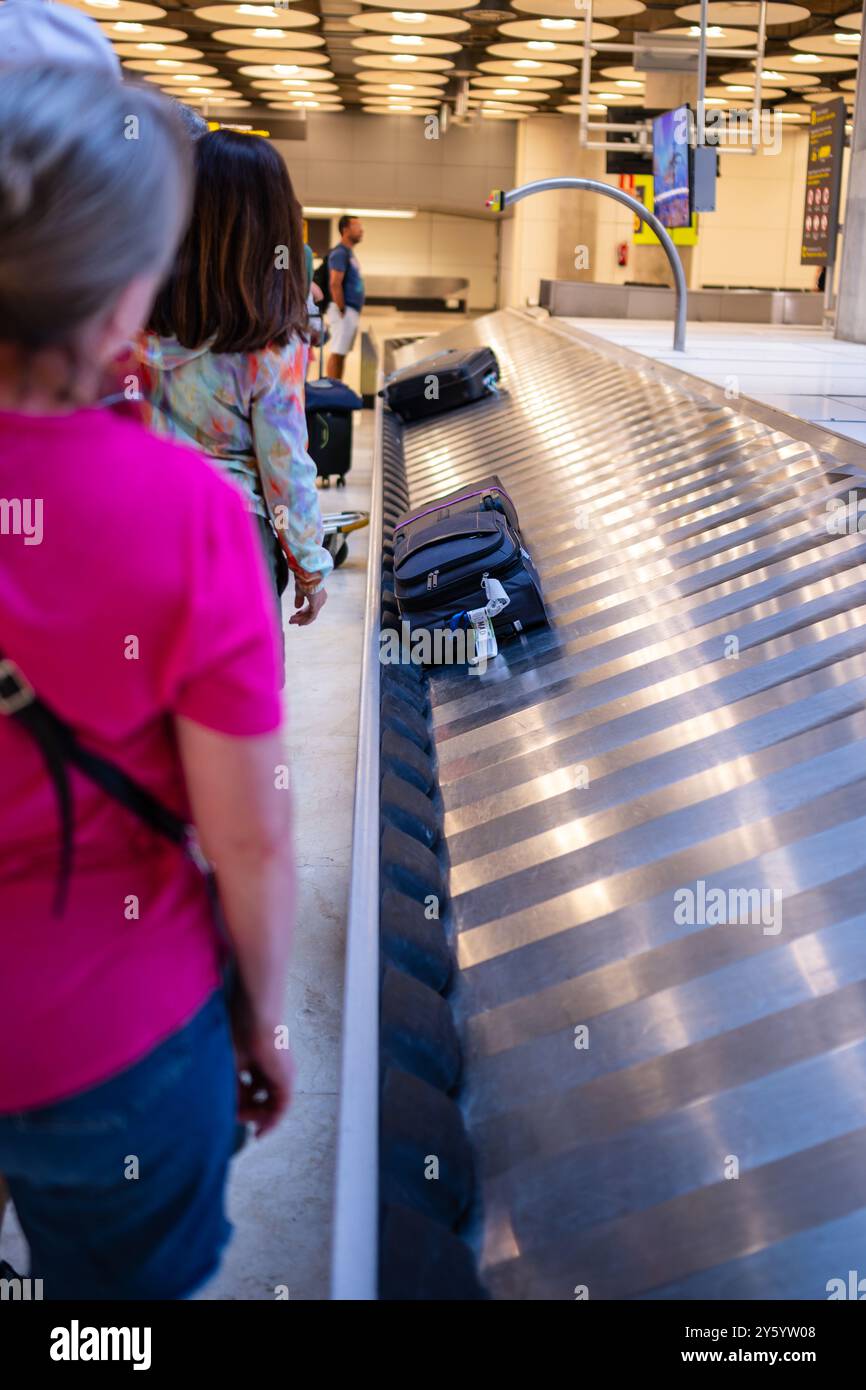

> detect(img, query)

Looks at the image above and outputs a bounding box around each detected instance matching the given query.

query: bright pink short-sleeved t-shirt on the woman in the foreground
[0,410,281,1113]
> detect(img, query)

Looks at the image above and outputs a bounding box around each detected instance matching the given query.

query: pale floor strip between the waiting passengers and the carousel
[195,410,373,1300]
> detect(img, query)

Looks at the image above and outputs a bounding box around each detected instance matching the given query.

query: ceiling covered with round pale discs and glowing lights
[68,0,860,121]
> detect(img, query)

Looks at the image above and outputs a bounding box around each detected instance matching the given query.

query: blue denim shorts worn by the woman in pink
[0,992,238,1300]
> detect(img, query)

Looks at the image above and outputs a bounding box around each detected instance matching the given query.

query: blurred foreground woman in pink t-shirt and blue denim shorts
[0,67,293,1298]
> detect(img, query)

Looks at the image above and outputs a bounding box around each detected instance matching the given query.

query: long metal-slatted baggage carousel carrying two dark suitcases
[334,310,866,1301]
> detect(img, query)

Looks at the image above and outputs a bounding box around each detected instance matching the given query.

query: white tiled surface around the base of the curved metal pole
[560,318,866,443]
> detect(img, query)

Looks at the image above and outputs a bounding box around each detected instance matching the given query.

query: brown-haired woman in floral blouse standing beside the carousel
[139,131,334,636]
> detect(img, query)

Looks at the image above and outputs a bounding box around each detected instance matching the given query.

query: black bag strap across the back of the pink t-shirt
[0,652,201,915]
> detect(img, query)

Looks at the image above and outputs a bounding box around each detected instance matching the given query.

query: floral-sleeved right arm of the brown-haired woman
[250,338,334,595]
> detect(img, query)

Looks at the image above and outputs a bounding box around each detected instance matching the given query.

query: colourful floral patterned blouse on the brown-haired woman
[136,334,334,589]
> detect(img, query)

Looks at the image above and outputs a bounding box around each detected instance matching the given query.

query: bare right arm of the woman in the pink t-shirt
[175,717,295,1133]
